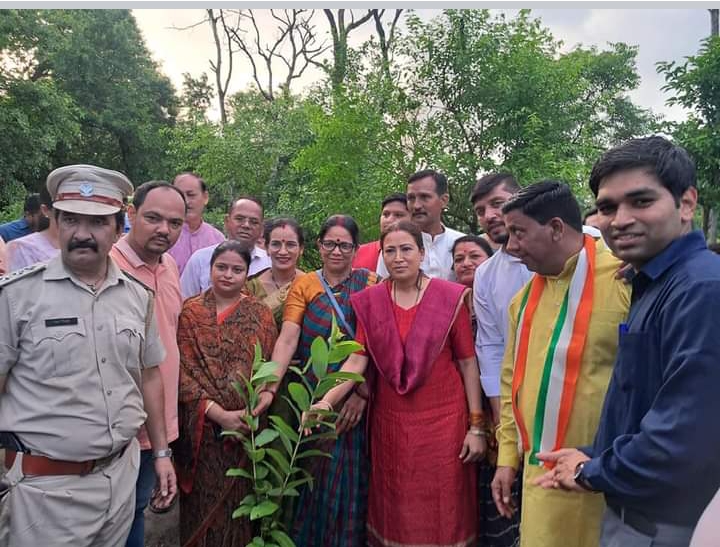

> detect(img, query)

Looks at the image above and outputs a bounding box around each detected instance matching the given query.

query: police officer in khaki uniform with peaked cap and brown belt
[0,165,176,547]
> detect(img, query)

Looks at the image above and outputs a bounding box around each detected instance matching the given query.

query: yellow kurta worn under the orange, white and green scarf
[498,240,630,547]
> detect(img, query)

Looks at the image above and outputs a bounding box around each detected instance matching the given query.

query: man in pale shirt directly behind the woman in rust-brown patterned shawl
[180,196,270,298]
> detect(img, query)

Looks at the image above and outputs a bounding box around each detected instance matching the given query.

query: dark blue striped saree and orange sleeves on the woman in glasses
[293,269,376,547]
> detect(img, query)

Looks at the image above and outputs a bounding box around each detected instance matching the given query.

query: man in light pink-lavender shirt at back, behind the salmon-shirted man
[168,173,225,275]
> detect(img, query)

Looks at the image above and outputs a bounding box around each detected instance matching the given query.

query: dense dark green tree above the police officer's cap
[0,10,178,199]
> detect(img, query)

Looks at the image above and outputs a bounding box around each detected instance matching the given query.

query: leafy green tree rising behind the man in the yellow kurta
[402,10,652,229]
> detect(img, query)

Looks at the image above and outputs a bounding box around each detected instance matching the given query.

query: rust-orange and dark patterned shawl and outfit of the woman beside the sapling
[175,289,277,547]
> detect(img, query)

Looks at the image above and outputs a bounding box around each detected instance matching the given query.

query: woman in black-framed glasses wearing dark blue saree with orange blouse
[260,215,377,547]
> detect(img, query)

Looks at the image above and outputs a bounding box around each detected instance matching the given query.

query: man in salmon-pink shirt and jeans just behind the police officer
[110,181,185,547]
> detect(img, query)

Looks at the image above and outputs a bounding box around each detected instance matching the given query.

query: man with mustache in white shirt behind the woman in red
[408,169,465,280]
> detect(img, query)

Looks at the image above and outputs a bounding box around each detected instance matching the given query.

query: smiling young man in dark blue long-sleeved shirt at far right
[538,137,720,547]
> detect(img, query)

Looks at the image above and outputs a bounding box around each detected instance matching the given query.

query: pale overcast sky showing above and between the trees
[133,8,710,120]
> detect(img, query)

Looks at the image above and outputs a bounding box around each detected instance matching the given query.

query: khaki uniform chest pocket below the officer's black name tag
[30,318,88,378]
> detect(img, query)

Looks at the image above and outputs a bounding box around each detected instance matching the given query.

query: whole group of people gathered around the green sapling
[0,137,720,547]
